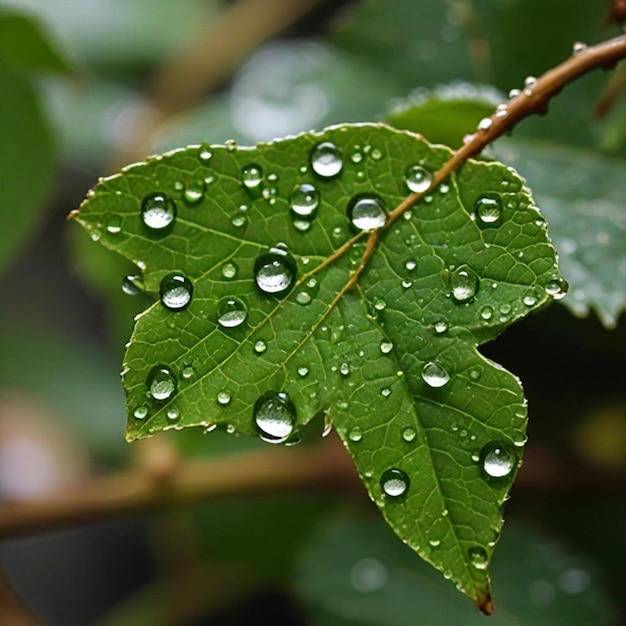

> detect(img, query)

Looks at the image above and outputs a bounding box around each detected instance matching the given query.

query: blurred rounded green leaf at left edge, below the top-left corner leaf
[0,61,54,272]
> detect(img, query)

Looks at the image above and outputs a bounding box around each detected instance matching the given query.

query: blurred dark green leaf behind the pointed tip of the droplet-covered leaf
[295,519,613,626]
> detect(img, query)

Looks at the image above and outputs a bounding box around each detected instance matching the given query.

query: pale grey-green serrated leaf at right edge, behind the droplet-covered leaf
[495,140,626,328]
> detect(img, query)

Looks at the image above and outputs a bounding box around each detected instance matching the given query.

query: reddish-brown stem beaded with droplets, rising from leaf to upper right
[384,35,626,228]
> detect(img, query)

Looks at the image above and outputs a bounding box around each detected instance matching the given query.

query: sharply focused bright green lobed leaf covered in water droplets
[74,125,562,611]
